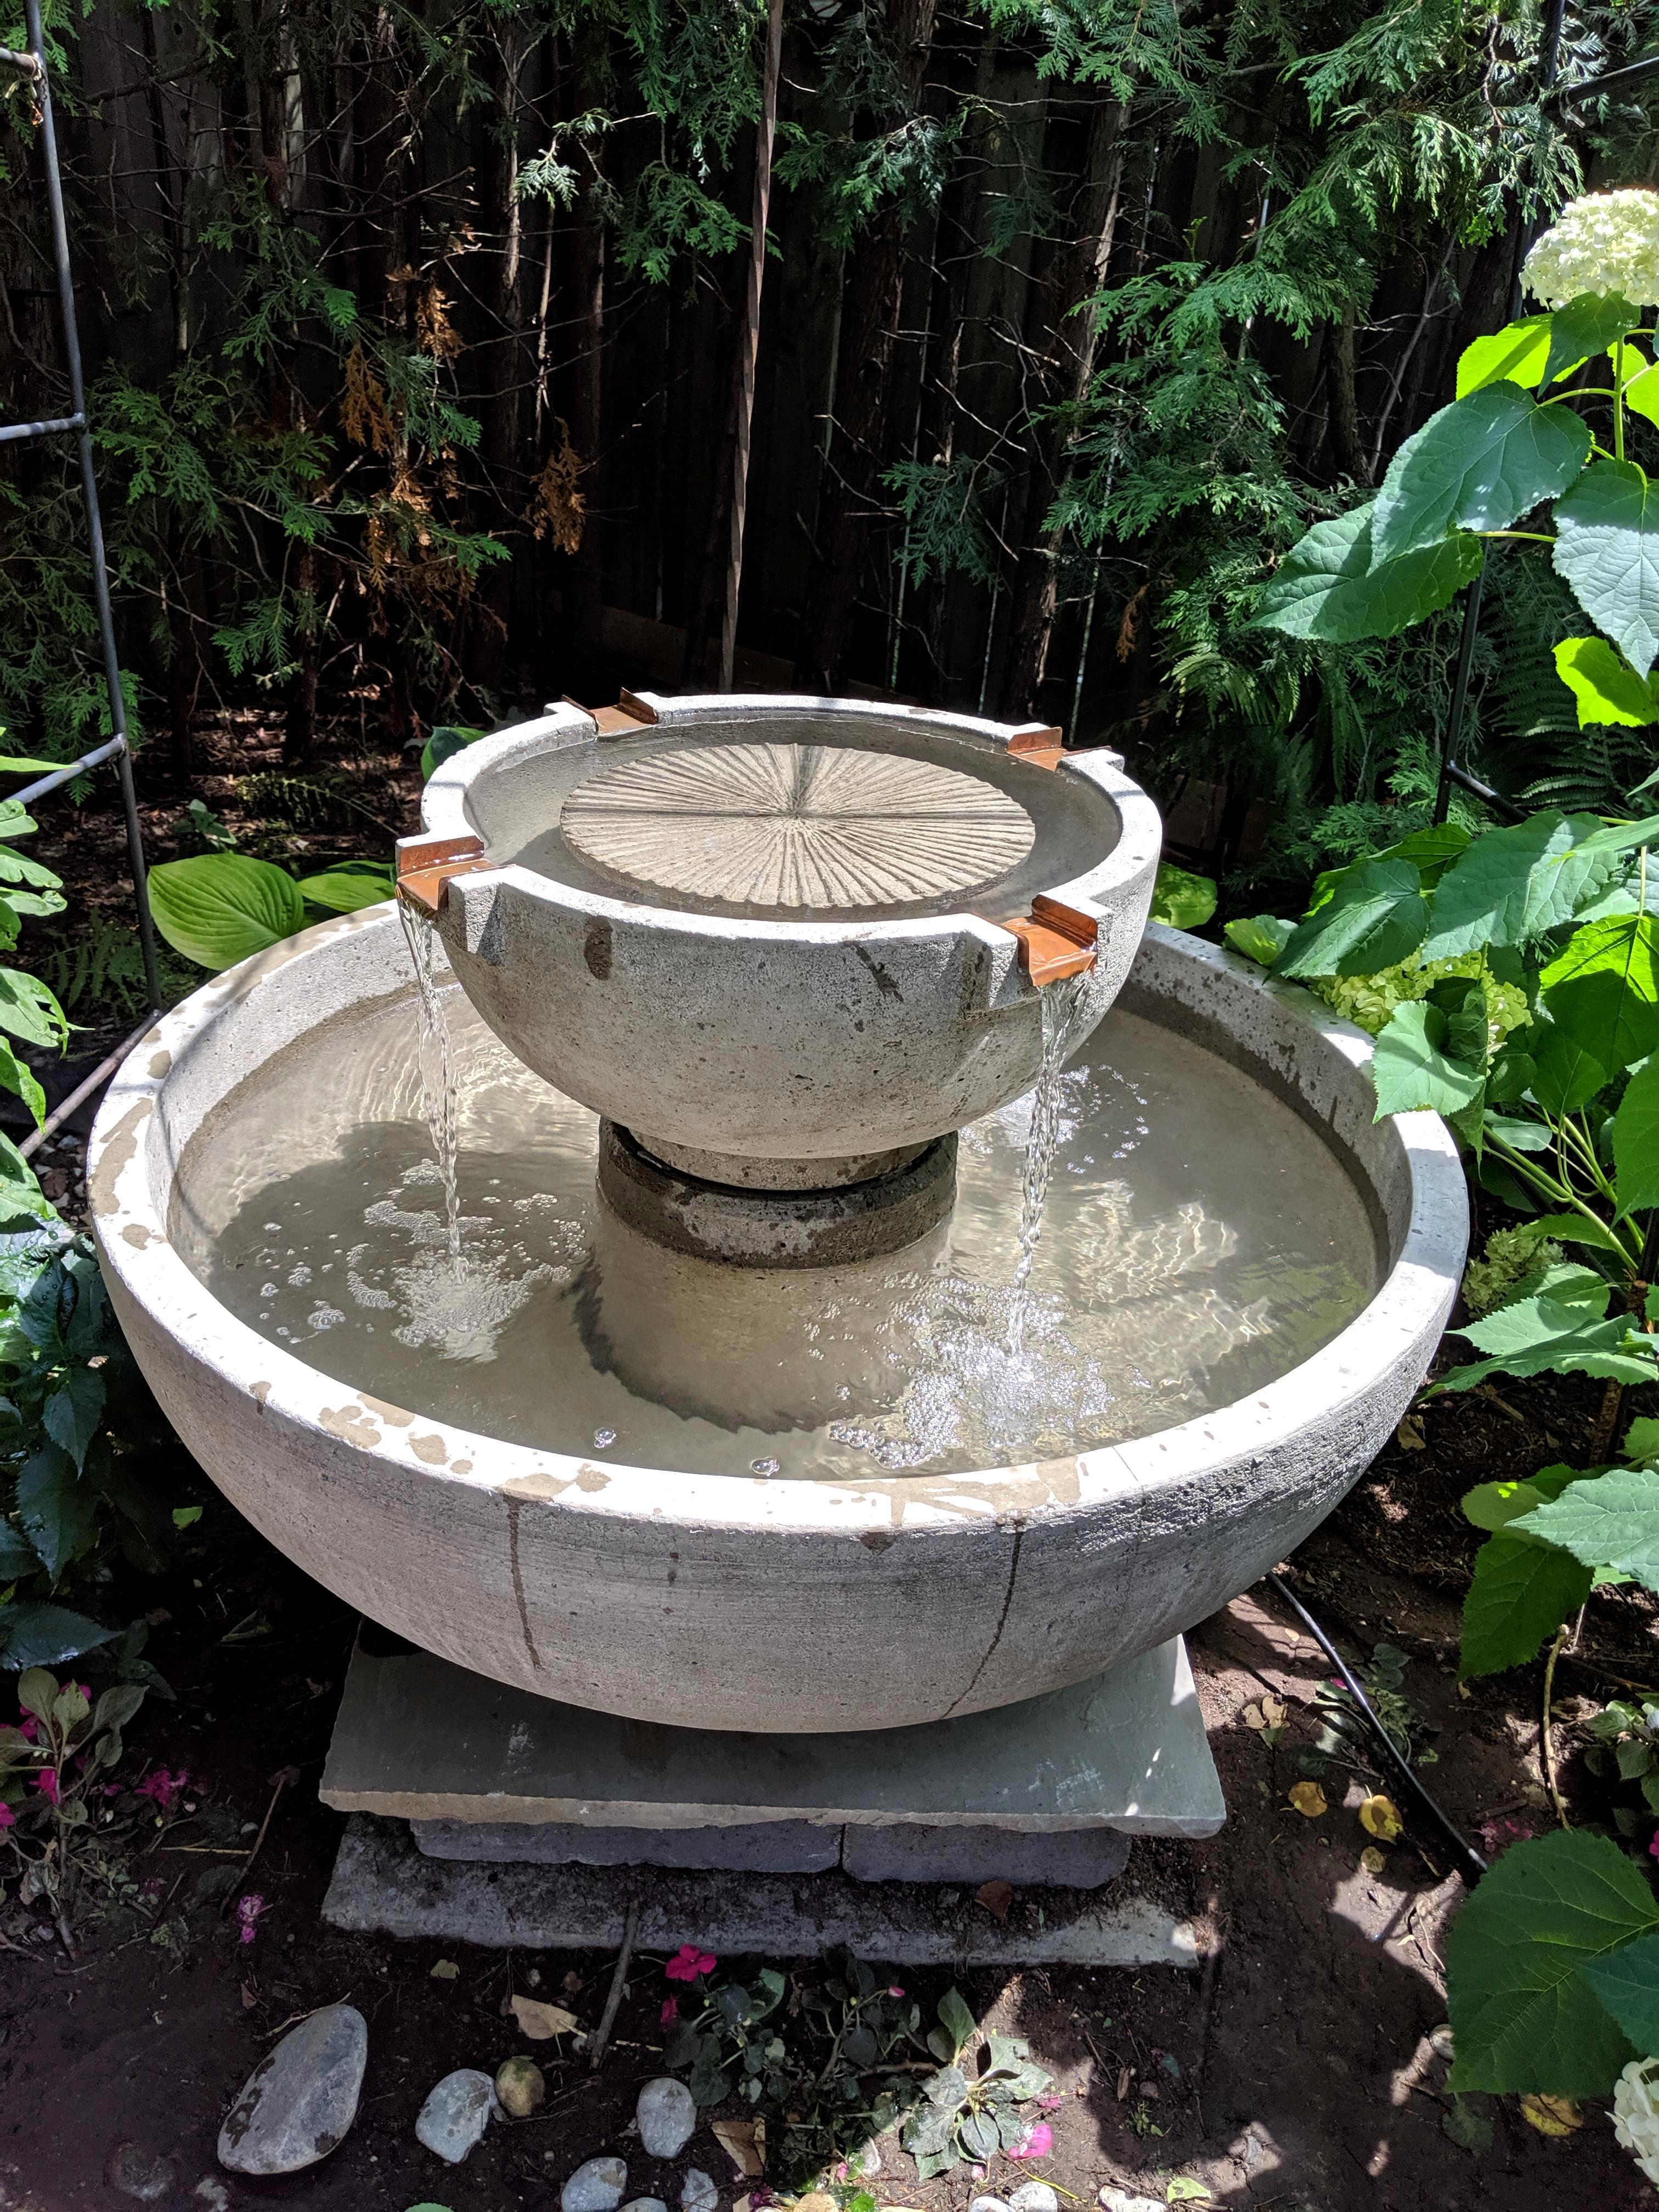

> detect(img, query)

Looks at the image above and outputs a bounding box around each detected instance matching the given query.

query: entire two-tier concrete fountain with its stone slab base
[91,695,1466,1957]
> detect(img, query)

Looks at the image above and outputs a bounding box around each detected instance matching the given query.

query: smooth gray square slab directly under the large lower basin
[321,1630,1226,1836]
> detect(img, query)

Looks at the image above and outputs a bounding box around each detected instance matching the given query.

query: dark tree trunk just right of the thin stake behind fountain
[797,0,936,690]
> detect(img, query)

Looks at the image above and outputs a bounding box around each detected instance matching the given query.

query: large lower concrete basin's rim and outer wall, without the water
[88,905,1466,1730]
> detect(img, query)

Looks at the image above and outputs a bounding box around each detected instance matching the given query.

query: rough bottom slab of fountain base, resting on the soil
[323,1814,1199,1968]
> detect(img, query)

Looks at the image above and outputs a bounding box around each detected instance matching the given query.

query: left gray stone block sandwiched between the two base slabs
[409,1820,840,1874]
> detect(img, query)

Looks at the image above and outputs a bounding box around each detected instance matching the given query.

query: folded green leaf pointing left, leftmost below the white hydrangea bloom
[1252,506,1484,644]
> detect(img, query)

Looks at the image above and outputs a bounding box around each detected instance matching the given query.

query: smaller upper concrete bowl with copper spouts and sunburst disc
[400,692,1161,1190]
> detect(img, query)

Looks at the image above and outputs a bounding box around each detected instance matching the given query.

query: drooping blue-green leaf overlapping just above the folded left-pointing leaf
[1372,383,1590,562]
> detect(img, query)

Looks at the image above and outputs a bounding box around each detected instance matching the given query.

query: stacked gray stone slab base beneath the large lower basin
[321,1628,1223,1964]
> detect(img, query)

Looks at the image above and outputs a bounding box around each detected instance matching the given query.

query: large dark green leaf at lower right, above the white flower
[1447,1829,1659,2097]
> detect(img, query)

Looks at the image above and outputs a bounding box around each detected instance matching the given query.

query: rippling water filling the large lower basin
[168,986,1378,1480]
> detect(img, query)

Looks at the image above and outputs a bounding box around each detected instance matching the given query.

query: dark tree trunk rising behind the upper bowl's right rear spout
[1002,99,1128,719]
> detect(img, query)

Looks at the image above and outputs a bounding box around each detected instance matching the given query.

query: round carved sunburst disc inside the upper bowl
[560,746,1037,909]
